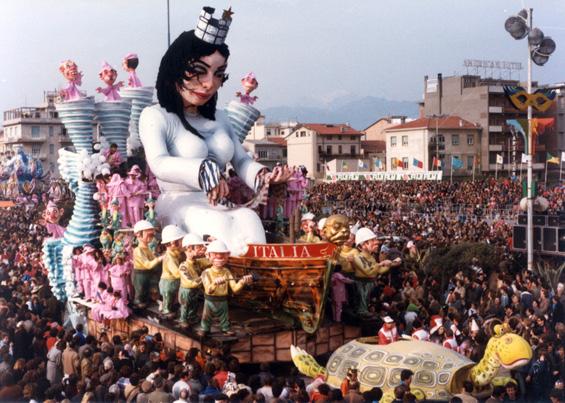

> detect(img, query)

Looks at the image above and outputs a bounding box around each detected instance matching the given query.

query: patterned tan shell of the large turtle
[326,338,475,400]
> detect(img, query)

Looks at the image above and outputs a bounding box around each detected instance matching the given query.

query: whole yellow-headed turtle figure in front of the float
[290,325,532,402]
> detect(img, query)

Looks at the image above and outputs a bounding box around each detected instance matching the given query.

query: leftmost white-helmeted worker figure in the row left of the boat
[133,220,163,308]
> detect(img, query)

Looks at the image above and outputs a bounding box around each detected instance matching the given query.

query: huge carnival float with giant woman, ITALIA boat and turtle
[39,7,531,399]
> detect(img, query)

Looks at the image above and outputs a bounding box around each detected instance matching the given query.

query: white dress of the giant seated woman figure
[139,105,265,255]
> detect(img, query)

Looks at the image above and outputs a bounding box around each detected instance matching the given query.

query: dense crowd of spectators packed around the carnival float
[0,178,565,403]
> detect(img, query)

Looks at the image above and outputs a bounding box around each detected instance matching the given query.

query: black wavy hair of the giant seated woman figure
[155,30,230,137]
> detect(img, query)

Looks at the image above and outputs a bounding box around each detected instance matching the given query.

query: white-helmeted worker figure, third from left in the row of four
[179,234,210,327]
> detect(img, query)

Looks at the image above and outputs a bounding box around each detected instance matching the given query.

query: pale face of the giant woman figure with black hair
[177,51,227,108]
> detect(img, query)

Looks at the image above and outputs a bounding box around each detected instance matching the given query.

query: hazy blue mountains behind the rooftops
[261,96,418,130]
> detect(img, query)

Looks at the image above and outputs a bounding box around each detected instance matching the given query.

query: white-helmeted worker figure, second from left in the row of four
[159,225,186,316]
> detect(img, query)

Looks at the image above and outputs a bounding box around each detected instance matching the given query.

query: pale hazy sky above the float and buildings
[0,0,565,123]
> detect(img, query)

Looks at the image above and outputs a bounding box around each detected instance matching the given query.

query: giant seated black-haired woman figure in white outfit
[140,12,284,255]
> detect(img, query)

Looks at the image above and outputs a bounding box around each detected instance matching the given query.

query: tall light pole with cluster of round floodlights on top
[504,8,556,270]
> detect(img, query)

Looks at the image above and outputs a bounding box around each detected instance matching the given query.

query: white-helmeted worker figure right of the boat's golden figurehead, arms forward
[350,227,392,316]
